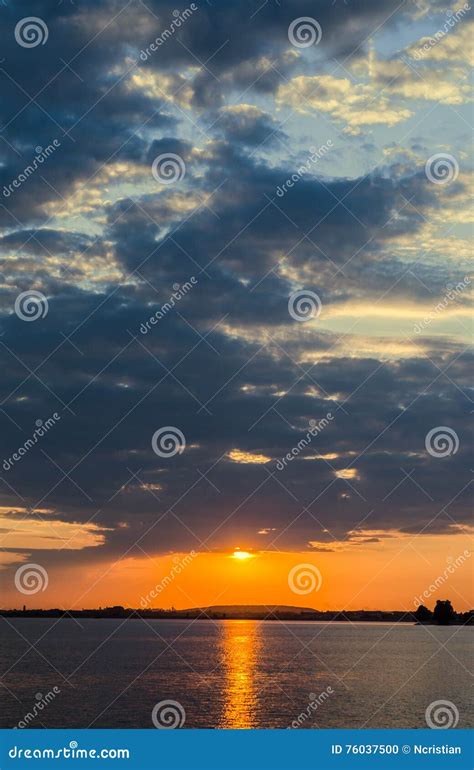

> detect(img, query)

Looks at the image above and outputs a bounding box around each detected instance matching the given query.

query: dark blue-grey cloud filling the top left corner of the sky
[0,2,176,226]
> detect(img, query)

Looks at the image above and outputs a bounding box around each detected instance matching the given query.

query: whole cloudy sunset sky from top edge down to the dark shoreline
[0,0,473,611]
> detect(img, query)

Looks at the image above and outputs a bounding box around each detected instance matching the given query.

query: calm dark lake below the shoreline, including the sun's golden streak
[0,618,474,729]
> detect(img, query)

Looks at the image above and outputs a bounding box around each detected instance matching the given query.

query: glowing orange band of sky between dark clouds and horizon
[2,533,474,611]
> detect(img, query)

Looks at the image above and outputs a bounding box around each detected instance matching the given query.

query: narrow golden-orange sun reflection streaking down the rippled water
[219,620,262,729]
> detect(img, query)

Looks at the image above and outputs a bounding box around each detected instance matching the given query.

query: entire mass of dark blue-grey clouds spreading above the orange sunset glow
[0,0,470,576]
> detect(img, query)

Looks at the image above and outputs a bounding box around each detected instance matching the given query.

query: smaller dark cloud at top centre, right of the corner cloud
[135,0,416,108]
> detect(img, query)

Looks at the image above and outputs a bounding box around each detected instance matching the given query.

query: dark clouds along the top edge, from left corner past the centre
[0,0,414,226]
